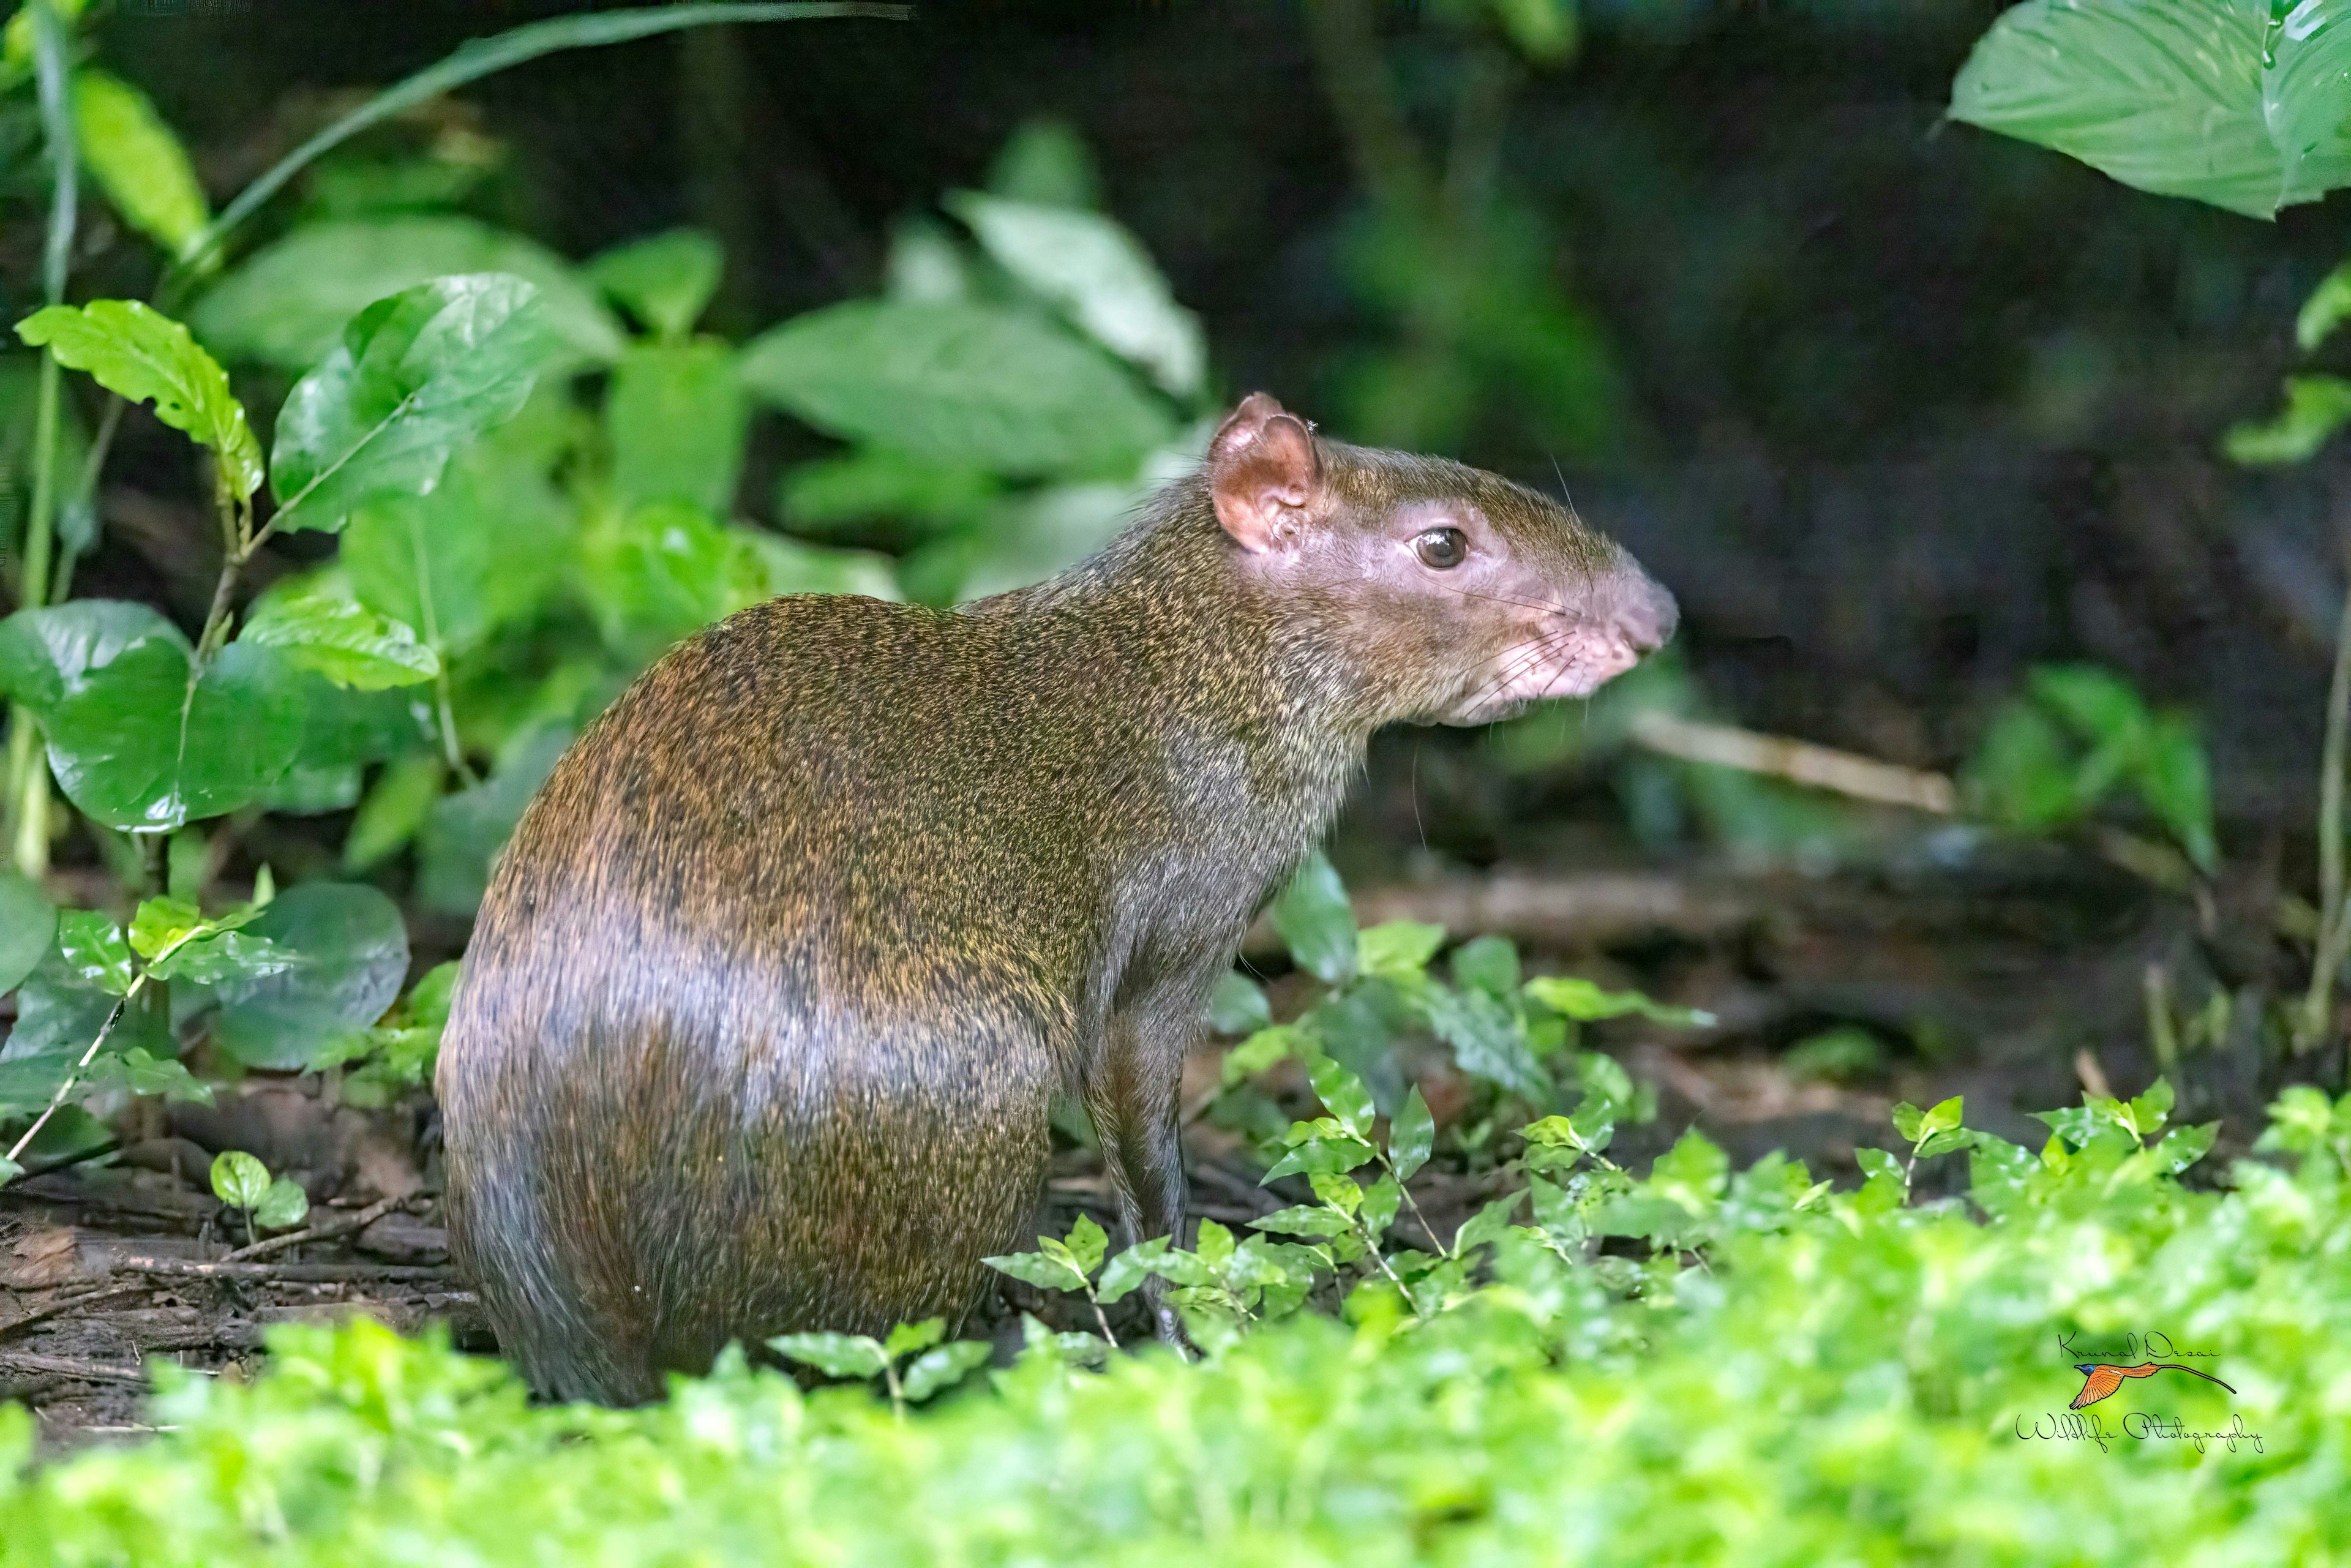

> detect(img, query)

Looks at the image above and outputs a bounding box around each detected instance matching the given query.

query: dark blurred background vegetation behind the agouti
[0,0,2344,1166]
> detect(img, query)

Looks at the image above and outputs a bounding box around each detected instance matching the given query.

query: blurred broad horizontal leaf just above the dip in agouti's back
[743,301,1176,477]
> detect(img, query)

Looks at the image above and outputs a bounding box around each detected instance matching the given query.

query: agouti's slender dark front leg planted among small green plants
[1086,1006,1199,1347]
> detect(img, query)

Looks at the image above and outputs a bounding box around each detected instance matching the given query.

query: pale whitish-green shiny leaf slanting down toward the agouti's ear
[945,190,1209,397]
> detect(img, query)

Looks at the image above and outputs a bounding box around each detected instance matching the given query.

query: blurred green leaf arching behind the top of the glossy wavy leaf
[188,216,623,372]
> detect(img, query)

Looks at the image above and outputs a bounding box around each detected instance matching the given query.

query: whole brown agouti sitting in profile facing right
[437,395,1674,1401]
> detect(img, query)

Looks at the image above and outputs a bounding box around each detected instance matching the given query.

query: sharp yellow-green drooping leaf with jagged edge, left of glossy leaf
[17,299,261,498]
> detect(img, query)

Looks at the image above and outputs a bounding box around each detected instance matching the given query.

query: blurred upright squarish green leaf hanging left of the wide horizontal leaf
[604,339,750,517]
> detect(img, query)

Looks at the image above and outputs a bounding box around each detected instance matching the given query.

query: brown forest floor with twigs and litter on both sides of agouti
[0,856,2273,1450]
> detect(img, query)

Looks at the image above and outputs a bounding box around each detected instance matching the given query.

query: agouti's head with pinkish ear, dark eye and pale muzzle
[1206,392,1676,724]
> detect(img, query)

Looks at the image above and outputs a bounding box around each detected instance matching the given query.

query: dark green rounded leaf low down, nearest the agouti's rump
[204,882,409,1070]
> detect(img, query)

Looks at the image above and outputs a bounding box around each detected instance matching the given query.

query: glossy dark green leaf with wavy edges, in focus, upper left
[271,272,555,531]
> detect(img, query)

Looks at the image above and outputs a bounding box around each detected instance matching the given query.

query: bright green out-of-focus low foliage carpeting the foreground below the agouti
[0,1091,2351,1563]
